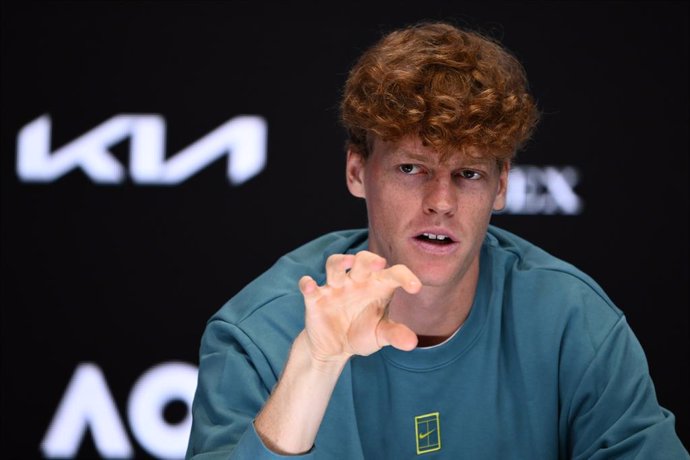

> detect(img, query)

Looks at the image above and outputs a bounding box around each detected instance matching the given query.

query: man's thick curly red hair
[340,22,539,162]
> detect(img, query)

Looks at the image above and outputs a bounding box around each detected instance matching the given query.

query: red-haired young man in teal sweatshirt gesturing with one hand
[187,23,688,459]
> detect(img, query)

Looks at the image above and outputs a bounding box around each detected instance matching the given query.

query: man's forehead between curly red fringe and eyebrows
[372,136,495,166]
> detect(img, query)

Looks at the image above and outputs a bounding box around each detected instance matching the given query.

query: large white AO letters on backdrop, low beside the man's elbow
[41,362,198,459]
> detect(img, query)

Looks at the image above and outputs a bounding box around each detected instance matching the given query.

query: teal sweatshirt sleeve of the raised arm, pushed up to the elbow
[185,320,313,460]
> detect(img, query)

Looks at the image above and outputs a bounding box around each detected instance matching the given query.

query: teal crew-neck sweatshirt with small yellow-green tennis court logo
[187,226,690,460]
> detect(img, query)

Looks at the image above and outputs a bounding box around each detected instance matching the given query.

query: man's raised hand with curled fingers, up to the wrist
[299,251,422,362]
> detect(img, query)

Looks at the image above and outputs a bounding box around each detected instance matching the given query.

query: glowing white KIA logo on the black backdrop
[17,114,267,185]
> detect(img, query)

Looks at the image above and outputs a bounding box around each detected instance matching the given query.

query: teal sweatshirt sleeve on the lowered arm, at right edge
[561,316,690,460]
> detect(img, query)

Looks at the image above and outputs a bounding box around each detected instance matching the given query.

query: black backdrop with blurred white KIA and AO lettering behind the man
[0,1,690,459]
